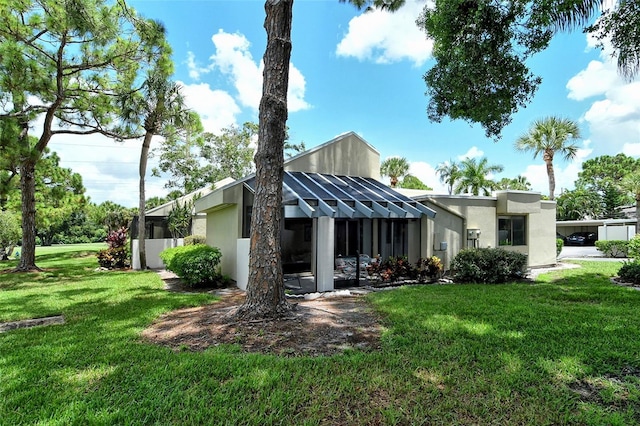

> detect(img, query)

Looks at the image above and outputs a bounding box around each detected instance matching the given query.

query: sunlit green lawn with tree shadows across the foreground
[0,246,640,425]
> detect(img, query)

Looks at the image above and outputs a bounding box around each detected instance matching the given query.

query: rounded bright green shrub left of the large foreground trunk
[160,244,224,287]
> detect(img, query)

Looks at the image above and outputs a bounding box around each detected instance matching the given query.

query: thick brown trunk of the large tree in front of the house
[237,0,293,319]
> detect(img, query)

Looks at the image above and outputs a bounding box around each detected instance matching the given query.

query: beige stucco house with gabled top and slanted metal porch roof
[195,132,555,291]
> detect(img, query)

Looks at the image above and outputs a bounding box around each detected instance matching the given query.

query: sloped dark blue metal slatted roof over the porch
[245,171,436,219]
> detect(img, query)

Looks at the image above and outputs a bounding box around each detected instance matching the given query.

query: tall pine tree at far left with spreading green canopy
[0,0,164,271]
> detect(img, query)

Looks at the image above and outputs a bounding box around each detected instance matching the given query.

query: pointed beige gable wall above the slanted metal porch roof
[284,133,380,180]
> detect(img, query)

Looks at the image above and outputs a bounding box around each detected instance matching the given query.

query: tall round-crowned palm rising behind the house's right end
[515,117,581,200]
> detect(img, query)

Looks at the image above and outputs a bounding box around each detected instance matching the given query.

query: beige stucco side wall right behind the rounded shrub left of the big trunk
[207,205,239,281]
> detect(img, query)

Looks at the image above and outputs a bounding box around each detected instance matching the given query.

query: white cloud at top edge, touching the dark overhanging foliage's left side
[336,0,433,66]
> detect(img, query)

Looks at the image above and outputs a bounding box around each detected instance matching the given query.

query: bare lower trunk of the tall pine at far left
[16,158,41,272]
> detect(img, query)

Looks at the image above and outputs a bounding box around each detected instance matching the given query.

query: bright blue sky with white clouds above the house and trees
[50,0,640,207]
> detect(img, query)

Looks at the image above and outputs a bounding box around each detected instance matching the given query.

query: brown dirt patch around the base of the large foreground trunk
[142,279,382,356]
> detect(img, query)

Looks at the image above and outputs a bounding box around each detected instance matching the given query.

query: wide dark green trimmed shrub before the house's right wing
[451,248,527,284]
